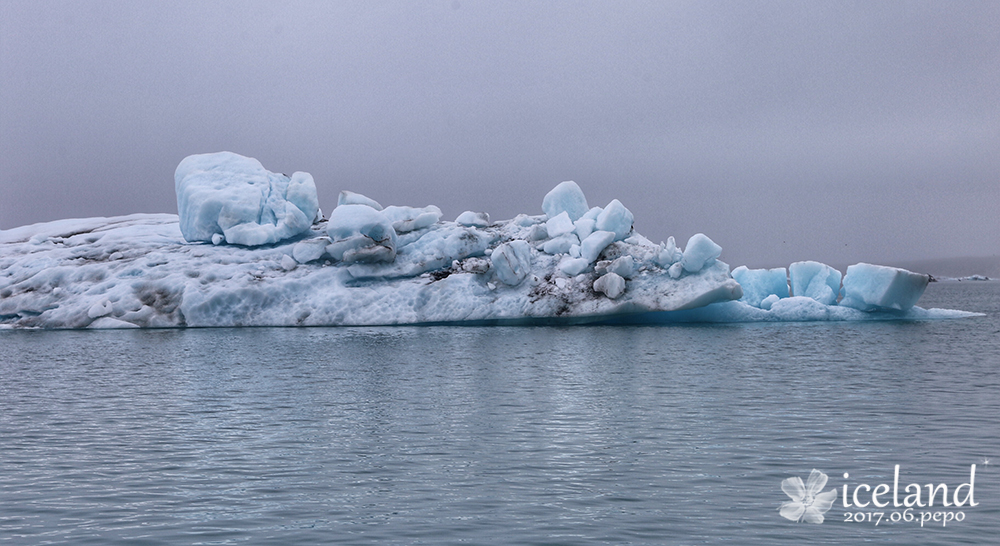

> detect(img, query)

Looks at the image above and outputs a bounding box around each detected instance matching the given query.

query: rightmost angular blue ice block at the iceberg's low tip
[840,263,930,311]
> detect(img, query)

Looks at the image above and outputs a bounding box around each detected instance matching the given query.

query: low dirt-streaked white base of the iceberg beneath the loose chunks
[0,207,972,328]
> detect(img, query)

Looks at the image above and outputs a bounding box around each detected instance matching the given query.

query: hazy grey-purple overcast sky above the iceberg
[0,0,1000,266]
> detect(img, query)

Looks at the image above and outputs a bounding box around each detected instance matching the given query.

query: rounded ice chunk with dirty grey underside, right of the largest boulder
[326,205,396,263]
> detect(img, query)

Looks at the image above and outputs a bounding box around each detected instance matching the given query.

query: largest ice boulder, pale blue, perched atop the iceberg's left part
[174,152,319,246]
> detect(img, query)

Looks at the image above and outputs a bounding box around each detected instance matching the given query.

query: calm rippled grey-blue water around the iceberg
[0,282,1000,545]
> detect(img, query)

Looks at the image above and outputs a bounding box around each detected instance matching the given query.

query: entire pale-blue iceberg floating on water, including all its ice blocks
[0,153,984,328]
